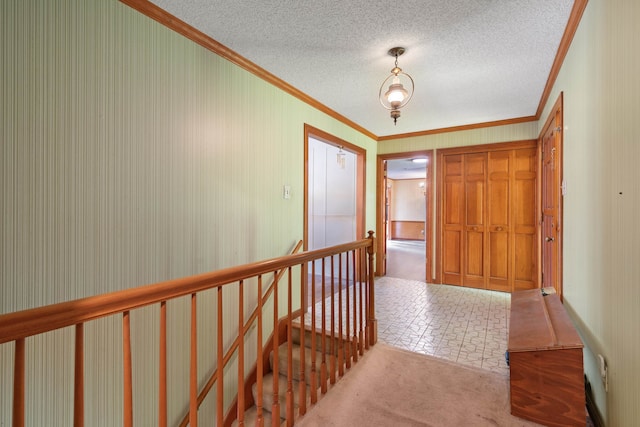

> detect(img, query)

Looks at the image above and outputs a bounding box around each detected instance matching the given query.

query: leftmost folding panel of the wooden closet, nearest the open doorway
[442,155,464,285]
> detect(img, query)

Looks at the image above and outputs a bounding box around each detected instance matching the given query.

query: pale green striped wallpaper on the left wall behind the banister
[0,0,376,426]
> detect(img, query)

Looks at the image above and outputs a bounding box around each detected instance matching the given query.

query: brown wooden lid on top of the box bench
[508,289,583,353]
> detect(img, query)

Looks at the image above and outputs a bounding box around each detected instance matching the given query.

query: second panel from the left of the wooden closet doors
[462,153,487,289]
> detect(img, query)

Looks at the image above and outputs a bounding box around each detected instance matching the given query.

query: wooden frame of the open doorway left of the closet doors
[375,150,434,283]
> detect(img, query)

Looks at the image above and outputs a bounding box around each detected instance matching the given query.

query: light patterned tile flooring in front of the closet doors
[375,277,511,375]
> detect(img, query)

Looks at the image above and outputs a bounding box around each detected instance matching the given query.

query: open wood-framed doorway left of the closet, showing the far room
[376,150,433,283]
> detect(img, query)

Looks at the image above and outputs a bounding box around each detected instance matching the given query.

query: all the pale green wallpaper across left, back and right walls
[0,0,640,426]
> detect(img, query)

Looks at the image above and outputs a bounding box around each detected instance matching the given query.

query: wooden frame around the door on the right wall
[538,92,564,301]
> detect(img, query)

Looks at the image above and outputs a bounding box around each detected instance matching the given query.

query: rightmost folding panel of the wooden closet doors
[512,148,538,291]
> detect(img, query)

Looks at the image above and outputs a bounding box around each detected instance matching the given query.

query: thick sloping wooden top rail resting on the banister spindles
[0,239,360,344]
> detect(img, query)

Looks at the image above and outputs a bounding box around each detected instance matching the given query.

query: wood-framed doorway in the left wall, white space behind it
[303,125,366,305]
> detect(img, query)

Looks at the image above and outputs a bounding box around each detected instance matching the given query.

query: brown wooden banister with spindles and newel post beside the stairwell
[0,232,377,427]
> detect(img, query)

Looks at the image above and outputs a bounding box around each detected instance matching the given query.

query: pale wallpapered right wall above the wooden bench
[540,0,640,426]
